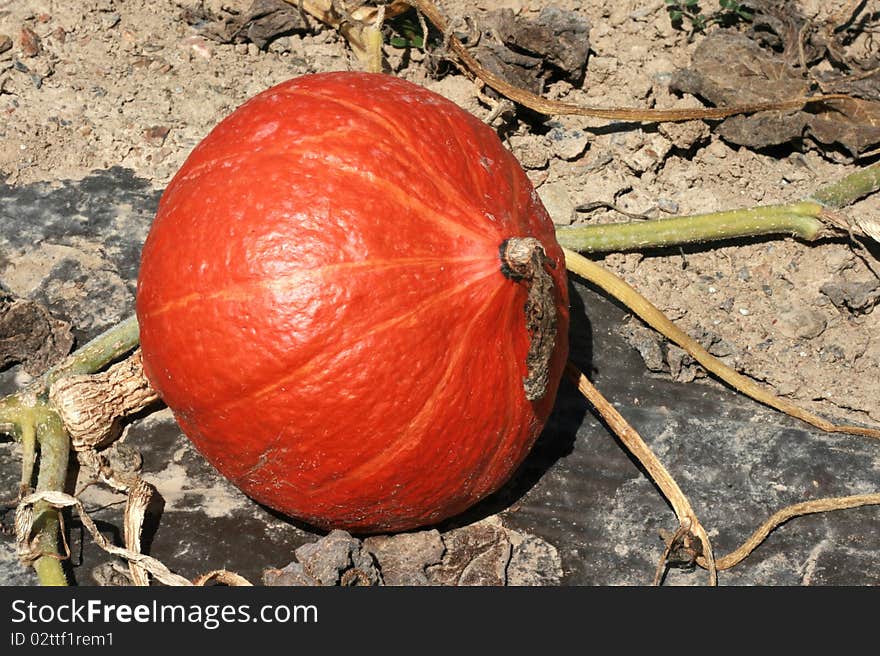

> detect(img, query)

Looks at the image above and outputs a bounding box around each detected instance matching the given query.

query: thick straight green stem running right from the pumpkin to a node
[556,202,826,253]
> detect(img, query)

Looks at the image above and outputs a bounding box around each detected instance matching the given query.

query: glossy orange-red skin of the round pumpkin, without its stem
[137,73,568,533]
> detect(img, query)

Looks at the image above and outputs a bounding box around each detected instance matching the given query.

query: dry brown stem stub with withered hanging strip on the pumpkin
[499,237,556,401]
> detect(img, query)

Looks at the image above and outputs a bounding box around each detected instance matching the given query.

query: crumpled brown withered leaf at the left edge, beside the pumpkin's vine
[0,291,73,376]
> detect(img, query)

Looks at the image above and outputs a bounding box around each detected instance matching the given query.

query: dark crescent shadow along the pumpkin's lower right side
[434,281,593,532]
